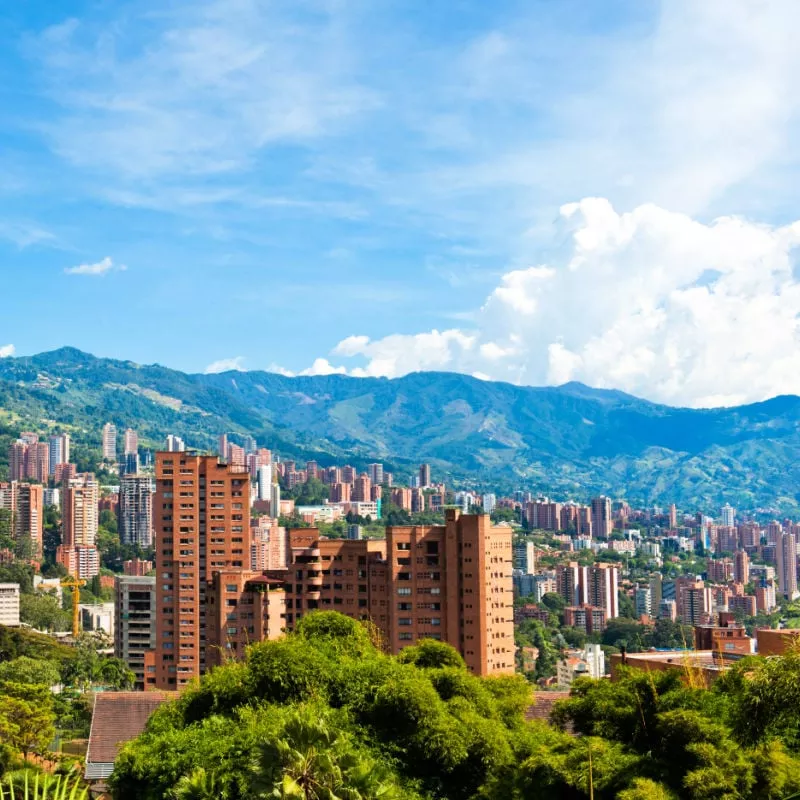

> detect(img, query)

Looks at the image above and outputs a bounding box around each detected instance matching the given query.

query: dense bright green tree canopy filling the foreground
[111,612,800,800]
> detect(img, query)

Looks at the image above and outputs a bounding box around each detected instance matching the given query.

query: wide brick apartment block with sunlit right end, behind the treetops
[276,509,514,675]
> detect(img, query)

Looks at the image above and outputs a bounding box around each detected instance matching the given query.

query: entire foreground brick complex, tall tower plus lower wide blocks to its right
[154,453,514,689]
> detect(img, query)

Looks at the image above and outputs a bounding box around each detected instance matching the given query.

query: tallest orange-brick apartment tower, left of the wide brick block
[154,453,250,689]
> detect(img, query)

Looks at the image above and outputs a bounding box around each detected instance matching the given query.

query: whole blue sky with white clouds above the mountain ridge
[0,0,800,407]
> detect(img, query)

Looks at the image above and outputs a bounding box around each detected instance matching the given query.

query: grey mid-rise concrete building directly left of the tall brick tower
[114,575,156,690]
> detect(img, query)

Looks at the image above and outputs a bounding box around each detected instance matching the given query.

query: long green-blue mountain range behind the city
[0,348,800,513]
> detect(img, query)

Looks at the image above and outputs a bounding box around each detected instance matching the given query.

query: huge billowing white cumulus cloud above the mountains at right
[326,197,800,406]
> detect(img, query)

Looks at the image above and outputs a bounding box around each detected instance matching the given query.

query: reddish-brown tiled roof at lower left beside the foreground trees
[86,692,177,765]
